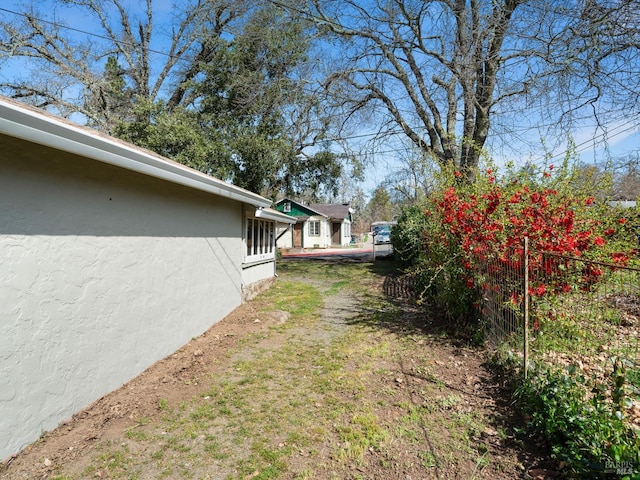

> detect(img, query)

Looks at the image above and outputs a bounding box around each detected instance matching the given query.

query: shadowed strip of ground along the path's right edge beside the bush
[280,257,556,478]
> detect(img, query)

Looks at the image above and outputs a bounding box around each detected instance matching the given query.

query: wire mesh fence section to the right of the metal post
[529,252,640,398]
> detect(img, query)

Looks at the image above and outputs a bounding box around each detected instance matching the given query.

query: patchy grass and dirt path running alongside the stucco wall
[0,262,542,480]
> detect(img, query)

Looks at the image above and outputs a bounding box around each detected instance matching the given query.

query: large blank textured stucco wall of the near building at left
[0,138,243,459]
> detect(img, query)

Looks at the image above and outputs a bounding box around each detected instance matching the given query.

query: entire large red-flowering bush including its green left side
[392,161,637,330]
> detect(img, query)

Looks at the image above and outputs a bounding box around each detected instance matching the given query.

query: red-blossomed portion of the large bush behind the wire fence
[425,166,635,303]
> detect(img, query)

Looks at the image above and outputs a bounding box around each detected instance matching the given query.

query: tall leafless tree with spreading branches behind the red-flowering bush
[290,0,640,179]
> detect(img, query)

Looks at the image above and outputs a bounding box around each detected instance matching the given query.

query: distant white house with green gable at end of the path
[276,198,353,248]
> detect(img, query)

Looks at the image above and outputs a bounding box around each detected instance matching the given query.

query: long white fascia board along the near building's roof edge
[0,99,271,207]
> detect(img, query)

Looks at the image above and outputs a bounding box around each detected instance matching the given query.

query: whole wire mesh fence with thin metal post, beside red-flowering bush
[479,242,640,424]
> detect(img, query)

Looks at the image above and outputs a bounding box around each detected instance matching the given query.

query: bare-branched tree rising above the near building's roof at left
[0,0,246,132]
